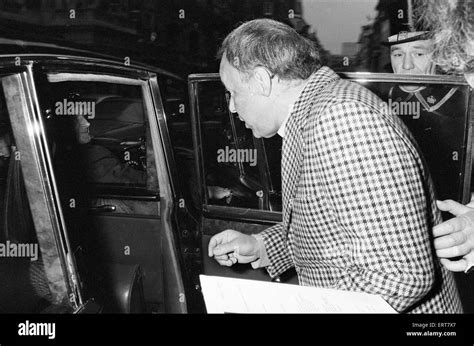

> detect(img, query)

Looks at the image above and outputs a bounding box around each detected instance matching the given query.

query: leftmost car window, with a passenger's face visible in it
[40,75,158,196]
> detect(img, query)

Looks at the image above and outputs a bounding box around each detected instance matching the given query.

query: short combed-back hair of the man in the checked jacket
[217,19,321,80]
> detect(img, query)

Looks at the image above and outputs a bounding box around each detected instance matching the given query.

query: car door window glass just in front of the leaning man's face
[193,81,268,209]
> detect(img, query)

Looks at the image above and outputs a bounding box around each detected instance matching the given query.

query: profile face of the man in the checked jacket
[219,56,279,138]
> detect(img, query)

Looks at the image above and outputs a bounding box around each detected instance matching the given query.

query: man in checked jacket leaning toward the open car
[208,19,462,313]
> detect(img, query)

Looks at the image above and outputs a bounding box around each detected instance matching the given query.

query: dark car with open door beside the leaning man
[0,37,473,313]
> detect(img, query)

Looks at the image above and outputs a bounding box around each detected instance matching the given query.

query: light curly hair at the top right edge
[415,0,474,73]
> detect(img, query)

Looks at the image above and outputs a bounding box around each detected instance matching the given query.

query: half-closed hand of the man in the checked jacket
[208,229,260,267]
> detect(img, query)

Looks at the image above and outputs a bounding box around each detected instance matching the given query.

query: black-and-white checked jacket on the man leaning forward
[261,67,462,313]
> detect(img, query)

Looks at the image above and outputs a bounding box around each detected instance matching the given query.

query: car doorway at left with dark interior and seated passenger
[35,62,187,313]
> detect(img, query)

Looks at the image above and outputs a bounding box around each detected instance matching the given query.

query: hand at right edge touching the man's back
[433,200,474,272]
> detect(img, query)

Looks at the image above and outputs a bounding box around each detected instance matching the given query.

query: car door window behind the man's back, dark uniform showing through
[356,80,470,200]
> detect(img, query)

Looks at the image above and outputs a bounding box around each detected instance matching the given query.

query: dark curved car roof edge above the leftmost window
[0,37,184,81]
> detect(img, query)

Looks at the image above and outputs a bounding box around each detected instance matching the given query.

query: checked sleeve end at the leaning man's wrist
[260,223,293,278]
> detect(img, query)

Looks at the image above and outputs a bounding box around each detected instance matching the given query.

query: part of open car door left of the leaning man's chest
[188,74,296,292]
